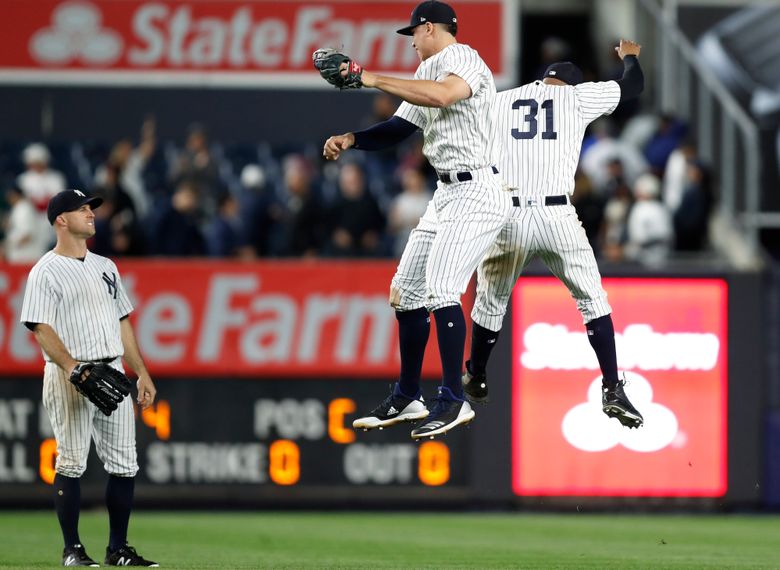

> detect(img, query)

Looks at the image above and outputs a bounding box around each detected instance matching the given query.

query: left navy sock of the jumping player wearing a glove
[395,308,431,398]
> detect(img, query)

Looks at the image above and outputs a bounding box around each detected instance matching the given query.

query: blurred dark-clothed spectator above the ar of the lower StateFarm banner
[273,154,326,257]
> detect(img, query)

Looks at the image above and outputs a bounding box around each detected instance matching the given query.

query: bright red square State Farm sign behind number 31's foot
[512,278,727,497]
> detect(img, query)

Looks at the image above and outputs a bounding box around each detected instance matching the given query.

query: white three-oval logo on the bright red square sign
[561,372,685,453]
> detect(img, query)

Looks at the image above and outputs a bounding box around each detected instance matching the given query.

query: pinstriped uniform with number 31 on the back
[471,81,620,331]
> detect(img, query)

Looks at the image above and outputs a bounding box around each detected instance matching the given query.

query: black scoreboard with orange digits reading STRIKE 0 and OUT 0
[0,378,469,503]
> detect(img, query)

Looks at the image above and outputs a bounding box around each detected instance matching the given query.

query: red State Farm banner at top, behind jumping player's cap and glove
[0,0,517,88]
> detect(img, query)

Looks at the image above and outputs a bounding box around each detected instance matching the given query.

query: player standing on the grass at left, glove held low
[21,190,158,566]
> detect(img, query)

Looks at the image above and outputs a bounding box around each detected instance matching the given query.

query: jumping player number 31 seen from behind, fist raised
[463,40,644,427]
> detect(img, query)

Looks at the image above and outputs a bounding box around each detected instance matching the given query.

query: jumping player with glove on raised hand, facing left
[314,1,512,439]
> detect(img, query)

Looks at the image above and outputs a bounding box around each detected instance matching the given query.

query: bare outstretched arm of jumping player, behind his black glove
[363,71,471,108]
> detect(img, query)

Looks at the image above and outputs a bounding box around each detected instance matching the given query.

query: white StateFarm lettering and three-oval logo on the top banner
[24,0,418,71]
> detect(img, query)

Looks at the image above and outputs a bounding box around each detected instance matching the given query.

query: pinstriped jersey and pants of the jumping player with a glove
[390,43,512,311]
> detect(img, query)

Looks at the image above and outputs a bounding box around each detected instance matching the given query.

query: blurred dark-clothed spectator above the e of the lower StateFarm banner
[151,181,206,257]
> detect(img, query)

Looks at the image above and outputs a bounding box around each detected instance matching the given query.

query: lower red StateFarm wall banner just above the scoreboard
[0,260,472,379]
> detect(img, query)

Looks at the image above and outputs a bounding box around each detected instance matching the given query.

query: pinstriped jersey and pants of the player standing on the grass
[21,251,138,477]
